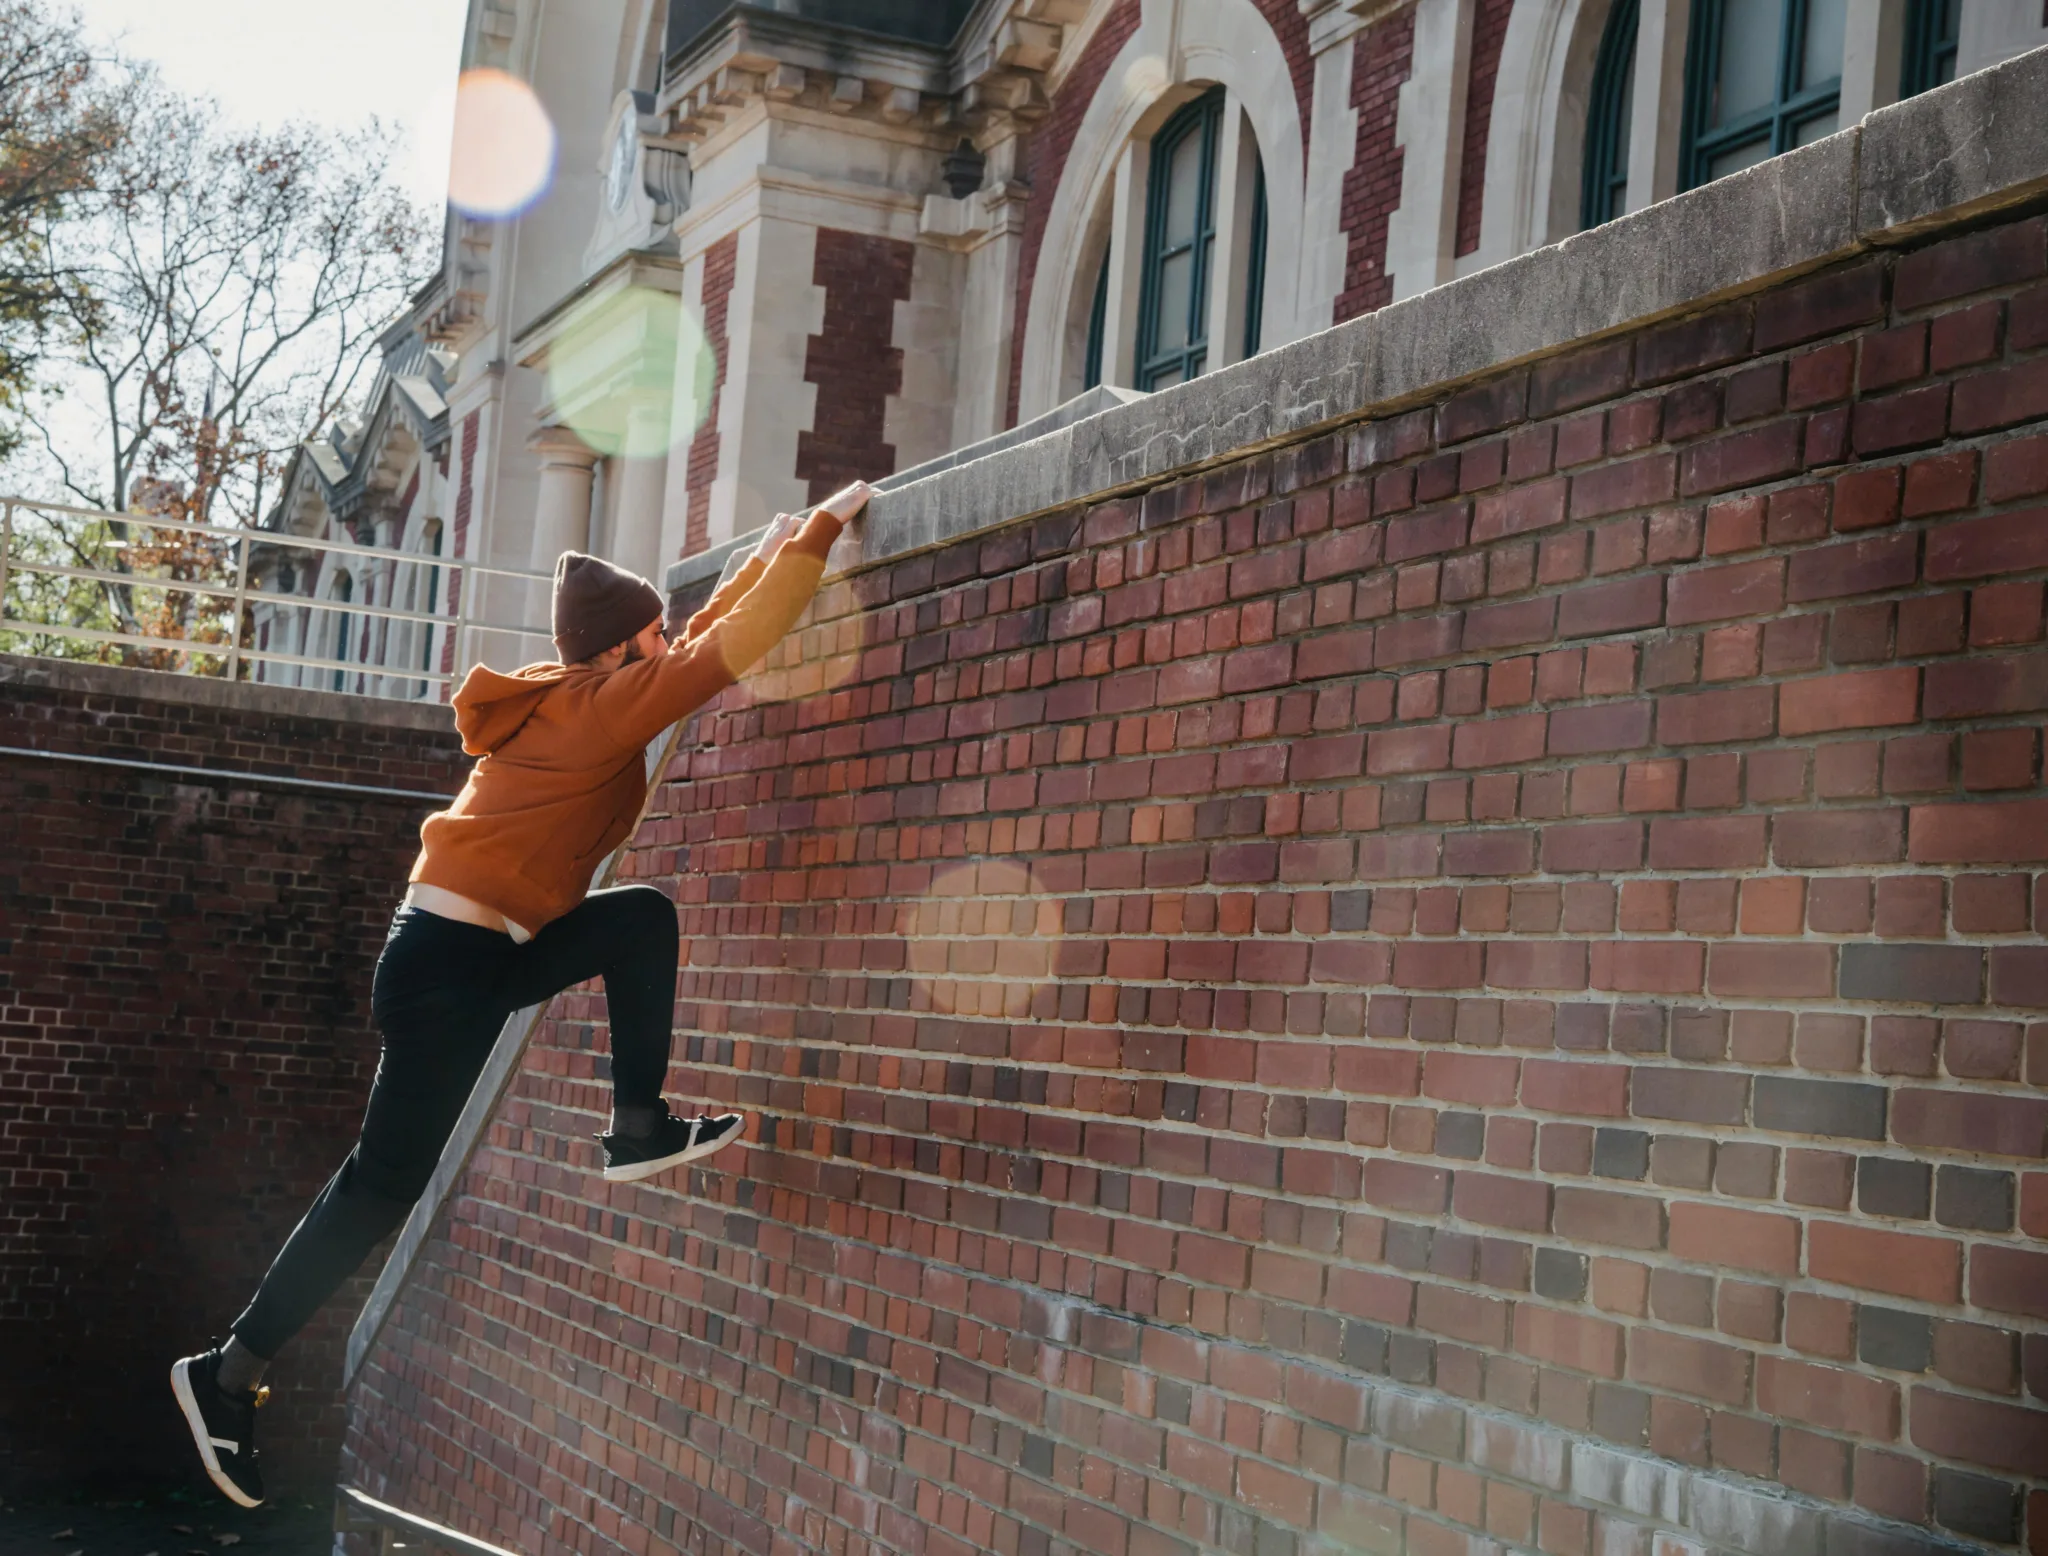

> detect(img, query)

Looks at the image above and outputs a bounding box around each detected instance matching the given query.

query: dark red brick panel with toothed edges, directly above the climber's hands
[797,227,915,502]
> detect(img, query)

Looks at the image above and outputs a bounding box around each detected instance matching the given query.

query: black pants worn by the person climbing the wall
[233,887,678,1357]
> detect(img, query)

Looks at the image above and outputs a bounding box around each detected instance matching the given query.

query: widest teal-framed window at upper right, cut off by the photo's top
[1681,0,1849,188]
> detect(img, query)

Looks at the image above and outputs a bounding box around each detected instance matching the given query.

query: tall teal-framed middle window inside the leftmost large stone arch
[1137,86,1223,389]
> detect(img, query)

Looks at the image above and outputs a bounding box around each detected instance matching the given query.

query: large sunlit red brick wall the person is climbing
[348,217,2048,1556]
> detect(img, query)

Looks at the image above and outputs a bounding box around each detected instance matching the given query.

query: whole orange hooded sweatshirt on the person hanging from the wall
[412,510,840,934]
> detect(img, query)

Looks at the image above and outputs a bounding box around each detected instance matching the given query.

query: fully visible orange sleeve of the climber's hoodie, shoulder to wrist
[594,510,842,749]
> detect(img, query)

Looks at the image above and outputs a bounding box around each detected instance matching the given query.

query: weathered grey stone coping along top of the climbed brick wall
[666,49,2048,594]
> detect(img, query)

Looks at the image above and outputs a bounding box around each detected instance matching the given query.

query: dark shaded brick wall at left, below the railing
[0,659,459,1495]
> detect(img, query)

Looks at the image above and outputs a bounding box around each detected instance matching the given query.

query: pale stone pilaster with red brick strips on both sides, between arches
[1386,0,1473,303]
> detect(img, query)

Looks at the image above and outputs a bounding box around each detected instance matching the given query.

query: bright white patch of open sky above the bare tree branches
[72,0,467,211]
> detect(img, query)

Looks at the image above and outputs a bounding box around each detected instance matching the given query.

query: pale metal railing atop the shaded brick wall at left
[0,495,553,700]
